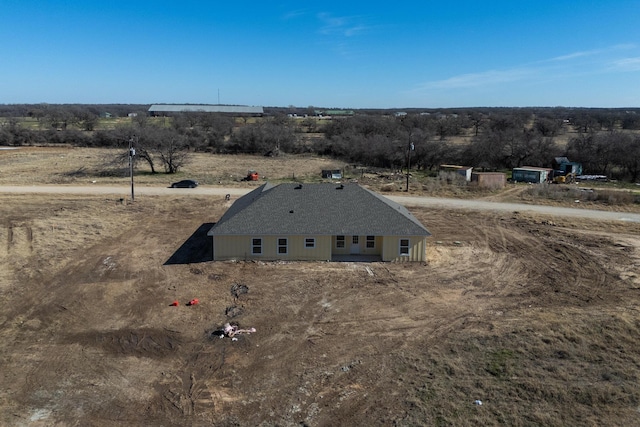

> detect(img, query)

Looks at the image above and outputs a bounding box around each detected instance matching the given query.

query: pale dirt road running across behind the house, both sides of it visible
[0,185,640,222]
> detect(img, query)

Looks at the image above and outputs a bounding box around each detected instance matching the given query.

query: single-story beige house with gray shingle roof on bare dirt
[208,183,431,262]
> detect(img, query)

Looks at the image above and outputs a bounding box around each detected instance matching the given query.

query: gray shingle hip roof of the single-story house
[209,183,431,236]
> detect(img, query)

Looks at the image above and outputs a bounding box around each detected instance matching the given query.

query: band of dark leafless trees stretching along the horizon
[0,105,640,182]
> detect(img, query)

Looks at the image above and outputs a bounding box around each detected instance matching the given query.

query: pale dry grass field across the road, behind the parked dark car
[0,147,345,186]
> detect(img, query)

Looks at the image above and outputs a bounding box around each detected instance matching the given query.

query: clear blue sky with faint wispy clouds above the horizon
[0,0,640,108]
